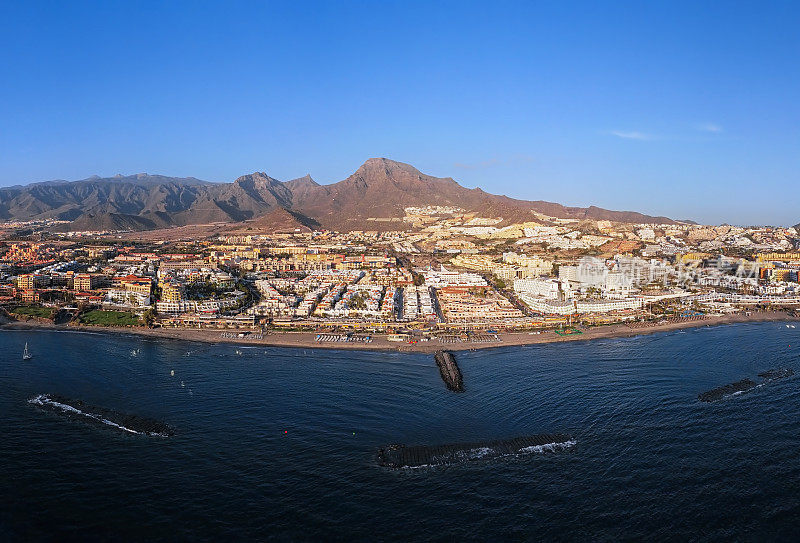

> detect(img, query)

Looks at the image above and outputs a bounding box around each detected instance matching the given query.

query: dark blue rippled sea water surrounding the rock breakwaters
[0,323,800,541]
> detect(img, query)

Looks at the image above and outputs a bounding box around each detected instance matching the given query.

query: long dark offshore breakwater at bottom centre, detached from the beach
[378,434,575,468]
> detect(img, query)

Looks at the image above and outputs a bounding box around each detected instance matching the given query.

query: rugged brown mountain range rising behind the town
[0,158,673,230]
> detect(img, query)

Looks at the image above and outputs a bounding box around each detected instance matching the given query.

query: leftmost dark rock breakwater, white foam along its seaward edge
[28,394,175,437]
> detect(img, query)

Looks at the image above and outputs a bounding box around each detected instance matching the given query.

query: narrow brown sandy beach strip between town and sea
[0,311,800,353]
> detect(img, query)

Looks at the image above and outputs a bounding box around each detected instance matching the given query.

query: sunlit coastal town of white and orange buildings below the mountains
[0,206,800,345]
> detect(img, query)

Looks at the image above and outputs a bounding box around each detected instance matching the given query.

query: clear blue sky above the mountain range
[0,0,800,224]
